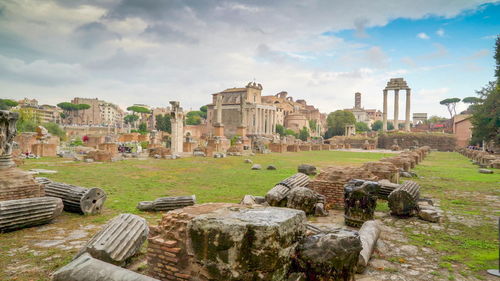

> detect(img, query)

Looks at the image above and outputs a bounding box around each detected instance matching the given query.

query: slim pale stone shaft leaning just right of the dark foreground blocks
[357,220,380,273]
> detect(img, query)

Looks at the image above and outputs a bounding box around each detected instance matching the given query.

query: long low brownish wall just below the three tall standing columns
[378,132,457,151]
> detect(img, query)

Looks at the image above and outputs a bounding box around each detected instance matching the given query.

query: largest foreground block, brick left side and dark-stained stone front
[147,203,306,280]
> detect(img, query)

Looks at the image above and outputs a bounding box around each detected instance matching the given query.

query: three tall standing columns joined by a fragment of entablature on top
[382,78,411,132]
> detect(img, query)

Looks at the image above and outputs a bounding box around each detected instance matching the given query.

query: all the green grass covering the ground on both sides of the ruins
[0,151,500,280]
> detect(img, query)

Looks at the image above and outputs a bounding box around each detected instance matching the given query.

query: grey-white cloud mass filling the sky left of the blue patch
[0,0,494,116]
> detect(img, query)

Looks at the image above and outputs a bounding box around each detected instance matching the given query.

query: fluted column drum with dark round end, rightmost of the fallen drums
[388,181,420,216]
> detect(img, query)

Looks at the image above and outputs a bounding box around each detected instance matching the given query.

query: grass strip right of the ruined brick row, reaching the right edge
[405,152,500,279]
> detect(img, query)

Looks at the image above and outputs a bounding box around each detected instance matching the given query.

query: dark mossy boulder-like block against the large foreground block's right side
[296,229,362,281]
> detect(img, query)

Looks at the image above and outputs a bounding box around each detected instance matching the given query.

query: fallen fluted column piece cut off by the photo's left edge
[0,197,63,232]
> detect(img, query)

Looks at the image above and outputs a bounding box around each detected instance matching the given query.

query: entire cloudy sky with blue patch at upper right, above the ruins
[0,0,500,116]
